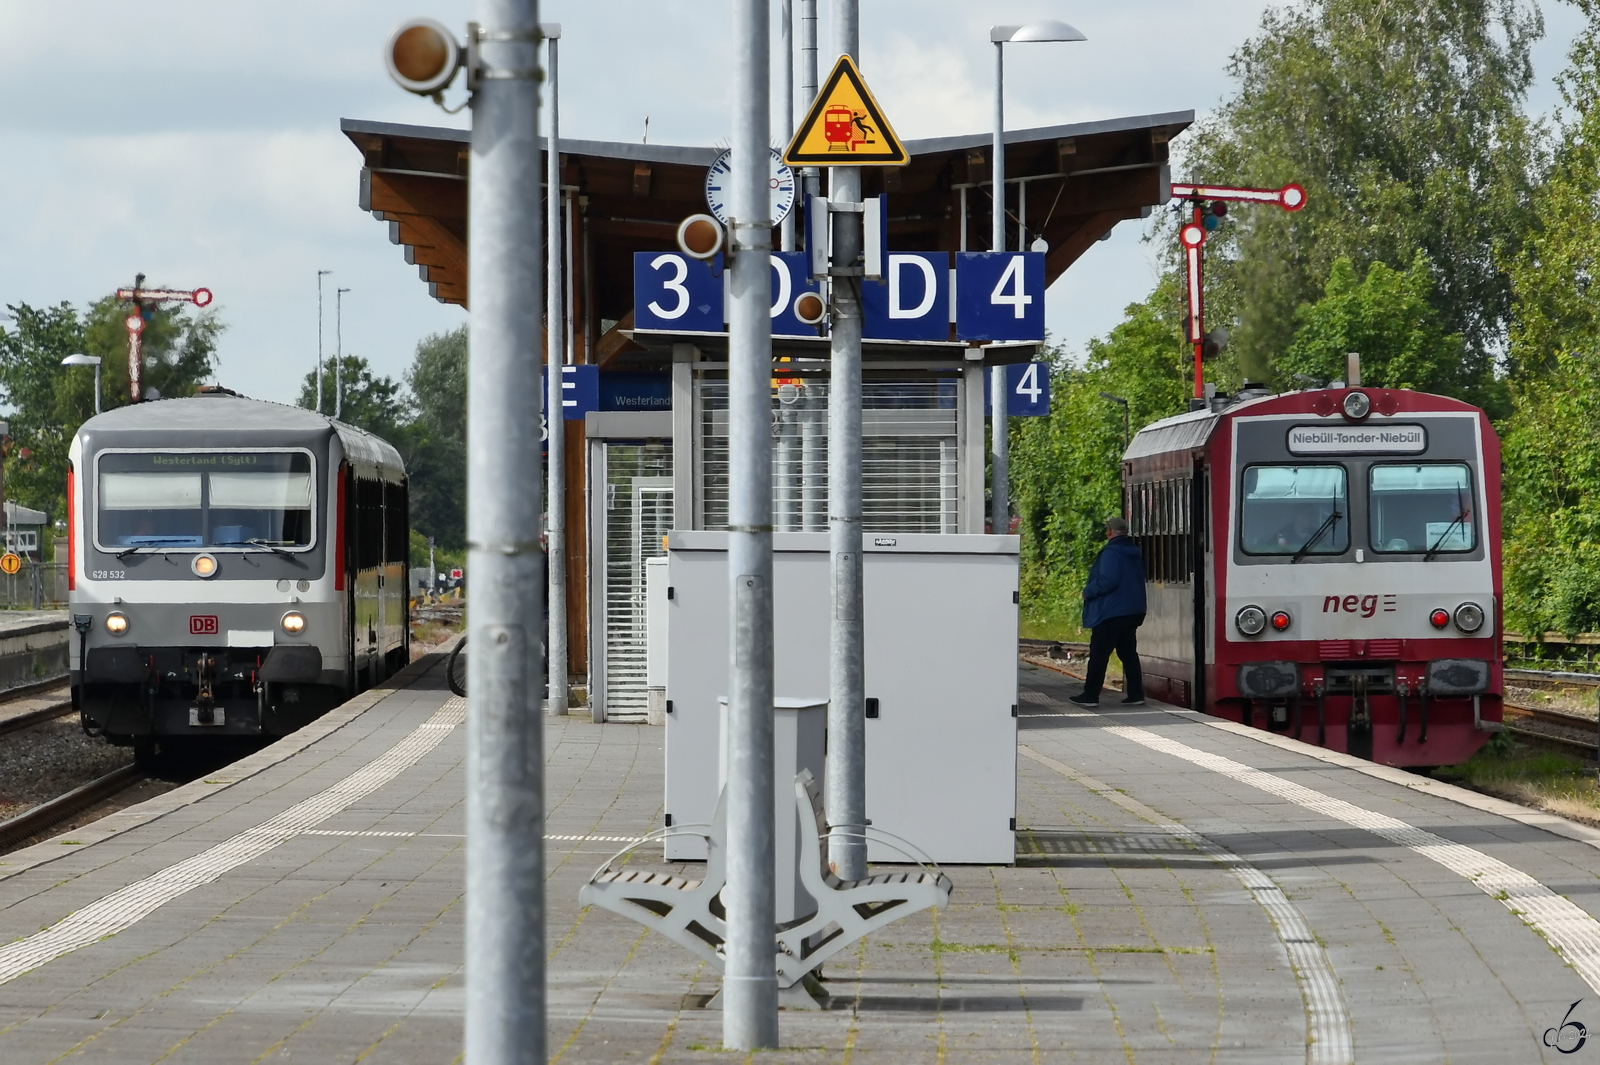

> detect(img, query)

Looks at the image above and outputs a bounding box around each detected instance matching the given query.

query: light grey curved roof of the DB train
[78,390,405,477]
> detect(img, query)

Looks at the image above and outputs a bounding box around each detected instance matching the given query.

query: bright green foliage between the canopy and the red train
[1011,280,1189,635]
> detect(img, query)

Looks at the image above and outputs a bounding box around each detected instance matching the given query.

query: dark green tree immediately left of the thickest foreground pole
[406,326,467,552]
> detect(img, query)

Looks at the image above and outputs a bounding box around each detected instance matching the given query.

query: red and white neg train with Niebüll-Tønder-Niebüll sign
[1122,387,1504,766]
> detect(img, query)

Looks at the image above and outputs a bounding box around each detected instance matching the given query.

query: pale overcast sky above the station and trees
[0,0,1581,401]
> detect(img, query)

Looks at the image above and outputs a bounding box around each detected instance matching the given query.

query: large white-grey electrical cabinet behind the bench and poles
[648,531,1018,865]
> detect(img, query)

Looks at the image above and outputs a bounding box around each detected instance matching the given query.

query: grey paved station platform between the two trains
[0,657,1600,1065]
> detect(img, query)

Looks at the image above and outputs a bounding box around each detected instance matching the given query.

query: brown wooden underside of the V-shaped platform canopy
[339,110,1194,363]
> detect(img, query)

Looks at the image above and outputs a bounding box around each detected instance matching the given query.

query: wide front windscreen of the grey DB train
[98,451,314,550]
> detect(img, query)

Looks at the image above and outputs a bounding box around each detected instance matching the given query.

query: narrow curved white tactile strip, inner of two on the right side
[1018,741,1355,1065]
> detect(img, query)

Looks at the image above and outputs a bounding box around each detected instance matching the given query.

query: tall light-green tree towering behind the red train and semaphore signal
[1174,0,1544,381]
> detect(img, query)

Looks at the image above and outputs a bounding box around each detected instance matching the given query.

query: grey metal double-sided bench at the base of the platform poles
[578,769,950,988]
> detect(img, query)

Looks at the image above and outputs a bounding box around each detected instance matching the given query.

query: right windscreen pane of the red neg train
[1371,462,1477,553]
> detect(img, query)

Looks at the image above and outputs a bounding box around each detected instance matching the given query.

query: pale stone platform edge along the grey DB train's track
[0,651,445,881]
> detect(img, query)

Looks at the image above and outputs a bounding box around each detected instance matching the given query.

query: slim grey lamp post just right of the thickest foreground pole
[544,27,568,718]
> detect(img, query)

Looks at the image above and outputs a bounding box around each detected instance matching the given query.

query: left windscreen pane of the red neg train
[1240,465,1350,555]
